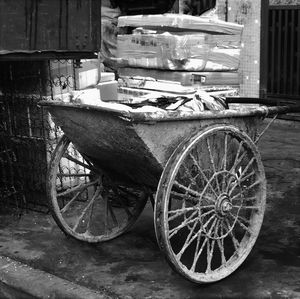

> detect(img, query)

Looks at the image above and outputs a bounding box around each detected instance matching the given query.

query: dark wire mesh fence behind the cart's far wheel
[0,60,77,212]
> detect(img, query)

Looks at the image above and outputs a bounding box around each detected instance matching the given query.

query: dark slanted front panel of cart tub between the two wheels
[49,107,162,188]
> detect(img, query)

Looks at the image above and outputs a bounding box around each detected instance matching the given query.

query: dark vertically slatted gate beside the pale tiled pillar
[261,5,300,103]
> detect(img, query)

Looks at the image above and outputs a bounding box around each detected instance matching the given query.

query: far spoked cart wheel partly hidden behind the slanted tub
[47,136,147,243]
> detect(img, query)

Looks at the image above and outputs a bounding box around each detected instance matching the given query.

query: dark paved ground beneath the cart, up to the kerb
[0,118,300,299]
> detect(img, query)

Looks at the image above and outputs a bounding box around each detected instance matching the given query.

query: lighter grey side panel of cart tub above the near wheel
[135,116,261,167]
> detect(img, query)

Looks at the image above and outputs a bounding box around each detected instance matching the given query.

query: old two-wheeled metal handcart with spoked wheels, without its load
[41,98,300,283]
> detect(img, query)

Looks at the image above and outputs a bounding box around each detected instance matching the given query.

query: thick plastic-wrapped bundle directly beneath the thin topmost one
[117,33,240,71]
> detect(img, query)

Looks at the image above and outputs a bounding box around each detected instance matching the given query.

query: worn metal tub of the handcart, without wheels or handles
[41,102,267,188]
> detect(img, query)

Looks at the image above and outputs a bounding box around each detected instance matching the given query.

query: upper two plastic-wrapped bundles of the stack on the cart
[117,14,243,72]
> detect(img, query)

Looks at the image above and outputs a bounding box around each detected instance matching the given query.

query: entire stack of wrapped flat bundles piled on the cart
[113,14,243,111]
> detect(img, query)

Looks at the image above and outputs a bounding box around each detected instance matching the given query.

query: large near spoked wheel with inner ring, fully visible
[154,125,266,283]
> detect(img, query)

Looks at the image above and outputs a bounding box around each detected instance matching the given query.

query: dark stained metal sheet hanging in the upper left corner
[0,0,101,54]
